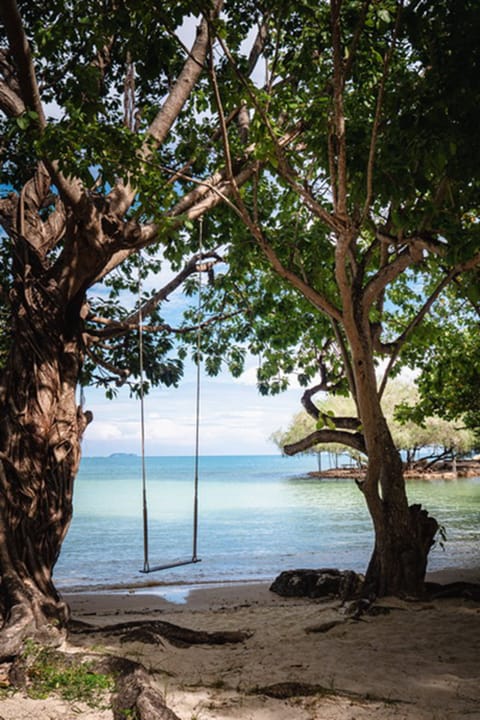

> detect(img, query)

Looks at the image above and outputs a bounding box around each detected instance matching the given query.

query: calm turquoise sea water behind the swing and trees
[55,456,480,590]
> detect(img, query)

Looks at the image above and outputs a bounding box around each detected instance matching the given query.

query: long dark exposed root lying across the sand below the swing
[68,620,253,648]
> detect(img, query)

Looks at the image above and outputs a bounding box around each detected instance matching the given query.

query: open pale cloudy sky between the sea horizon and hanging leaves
[79,365,302,456]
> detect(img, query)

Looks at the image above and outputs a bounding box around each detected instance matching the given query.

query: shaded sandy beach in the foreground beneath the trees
[0,570,480,720]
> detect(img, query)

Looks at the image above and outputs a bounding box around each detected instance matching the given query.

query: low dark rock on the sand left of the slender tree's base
[270,568,363,600]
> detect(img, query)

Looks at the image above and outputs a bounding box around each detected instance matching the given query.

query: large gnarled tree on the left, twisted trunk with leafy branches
[0,0,282,657]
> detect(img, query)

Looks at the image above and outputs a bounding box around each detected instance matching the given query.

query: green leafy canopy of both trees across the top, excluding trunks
[1,0,480,404]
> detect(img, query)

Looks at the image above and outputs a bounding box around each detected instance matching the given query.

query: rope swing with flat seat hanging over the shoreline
[138,218,206,573]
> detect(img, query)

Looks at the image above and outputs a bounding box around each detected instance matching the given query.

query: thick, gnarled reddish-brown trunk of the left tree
[0,262,89,658]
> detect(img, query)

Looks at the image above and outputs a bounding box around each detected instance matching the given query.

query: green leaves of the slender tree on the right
[188,2,480,428]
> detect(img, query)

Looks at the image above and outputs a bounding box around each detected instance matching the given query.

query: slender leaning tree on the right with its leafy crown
[196,0,480,595]
